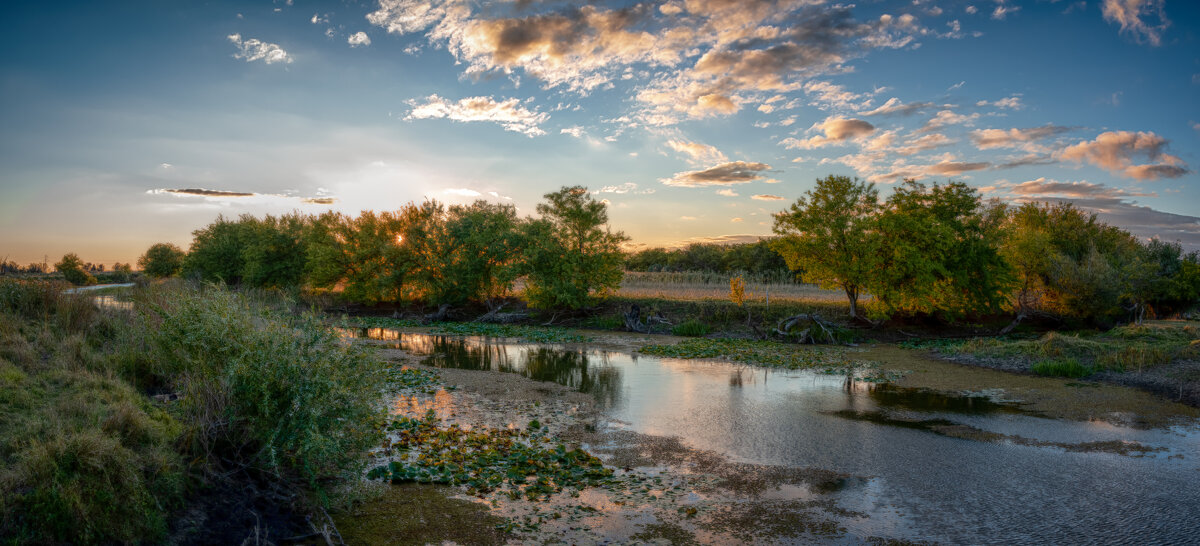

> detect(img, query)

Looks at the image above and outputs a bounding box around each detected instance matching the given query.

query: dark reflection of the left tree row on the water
[425,336,622,407]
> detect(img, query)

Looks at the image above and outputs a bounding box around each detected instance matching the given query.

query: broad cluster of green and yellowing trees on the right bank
[769,176,1200,325]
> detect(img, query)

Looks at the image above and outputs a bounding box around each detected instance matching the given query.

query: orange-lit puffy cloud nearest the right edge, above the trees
[1057,131,1190,180]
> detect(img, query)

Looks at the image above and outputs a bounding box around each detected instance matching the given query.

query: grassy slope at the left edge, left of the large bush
[0,280,184,544]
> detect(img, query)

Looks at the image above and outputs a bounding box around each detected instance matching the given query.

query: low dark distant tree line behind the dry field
[625,239,793,278]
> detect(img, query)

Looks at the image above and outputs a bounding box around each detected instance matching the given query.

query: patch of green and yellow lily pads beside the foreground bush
[367,410,613,500]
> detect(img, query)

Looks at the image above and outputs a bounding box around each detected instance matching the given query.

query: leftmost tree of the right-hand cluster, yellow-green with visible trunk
[770,175,880,318]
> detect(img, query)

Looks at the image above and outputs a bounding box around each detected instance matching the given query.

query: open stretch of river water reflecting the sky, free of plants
[362,330,1200,544]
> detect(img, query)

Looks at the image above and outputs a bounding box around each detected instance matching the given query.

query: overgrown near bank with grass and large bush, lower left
[0,278,388,544]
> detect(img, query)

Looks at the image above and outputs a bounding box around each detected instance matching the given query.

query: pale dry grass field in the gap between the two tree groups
[614,271,846,302]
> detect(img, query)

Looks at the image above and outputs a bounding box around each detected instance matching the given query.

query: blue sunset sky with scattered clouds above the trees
[0,0,1200,264]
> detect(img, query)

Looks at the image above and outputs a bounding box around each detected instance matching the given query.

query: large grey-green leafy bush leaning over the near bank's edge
[137,282,386,484]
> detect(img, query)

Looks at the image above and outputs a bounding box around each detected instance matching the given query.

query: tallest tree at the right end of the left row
[522,186,629,308]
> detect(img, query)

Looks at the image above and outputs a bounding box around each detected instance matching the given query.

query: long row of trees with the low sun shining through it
[139,186,628,308]
